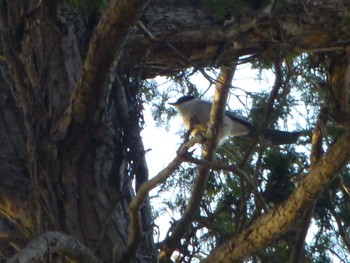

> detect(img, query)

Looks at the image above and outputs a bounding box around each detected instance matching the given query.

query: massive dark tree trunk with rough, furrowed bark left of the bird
[0,1,155,262]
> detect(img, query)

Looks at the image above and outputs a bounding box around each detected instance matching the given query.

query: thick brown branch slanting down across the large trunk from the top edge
[56,0,150,137]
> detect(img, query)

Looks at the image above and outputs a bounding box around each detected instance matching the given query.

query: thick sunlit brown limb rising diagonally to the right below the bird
[203,131,350,263]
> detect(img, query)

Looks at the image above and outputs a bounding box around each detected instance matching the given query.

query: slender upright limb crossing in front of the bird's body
[159,63,236,262]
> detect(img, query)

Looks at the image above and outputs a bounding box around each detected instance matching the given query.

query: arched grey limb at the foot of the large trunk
[7,231,101,263]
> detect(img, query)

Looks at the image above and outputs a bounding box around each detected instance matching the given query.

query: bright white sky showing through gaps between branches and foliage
[141,64,340,260]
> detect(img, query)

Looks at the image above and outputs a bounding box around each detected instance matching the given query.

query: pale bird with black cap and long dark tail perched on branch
[169,96,302,145]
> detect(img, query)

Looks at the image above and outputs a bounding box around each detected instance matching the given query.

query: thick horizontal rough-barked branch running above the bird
[121,0,350,77]
